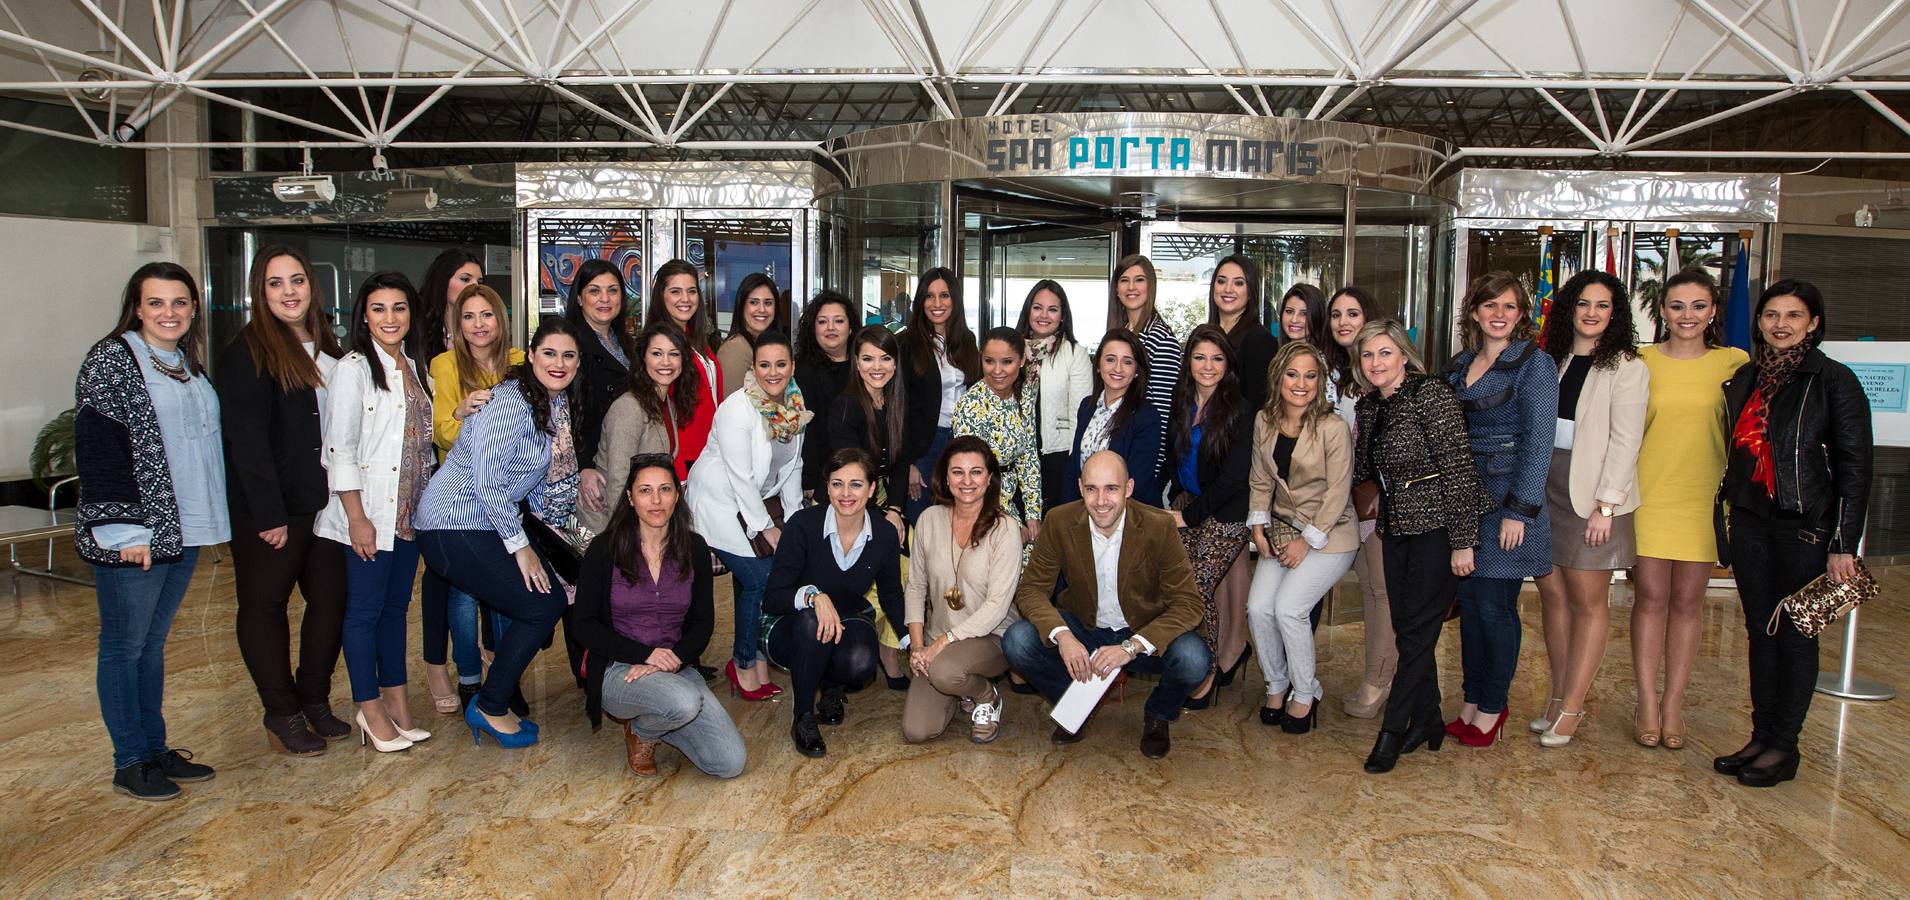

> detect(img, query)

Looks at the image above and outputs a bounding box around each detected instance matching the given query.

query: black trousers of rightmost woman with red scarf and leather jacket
[1730,506,1830,751]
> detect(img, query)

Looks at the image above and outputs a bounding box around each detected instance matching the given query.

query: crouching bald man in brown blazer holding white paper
[1001,451,1213,759]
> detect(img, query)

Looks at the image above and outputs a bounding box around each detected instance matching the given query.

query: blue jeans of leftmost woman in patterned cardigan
[94,546,199,768]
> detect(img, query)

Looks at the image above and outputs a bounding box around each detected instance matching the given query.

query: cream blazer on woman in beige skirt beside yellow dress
[1559,357,1652,518]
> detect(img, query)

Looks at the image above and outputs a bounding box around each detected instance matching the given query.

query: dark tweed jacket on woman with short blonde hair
[1352,373,1497,550]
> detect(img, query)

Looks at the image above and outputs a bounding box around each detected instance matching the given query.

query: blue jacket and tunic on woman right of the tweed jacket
[1446,340,1559,579]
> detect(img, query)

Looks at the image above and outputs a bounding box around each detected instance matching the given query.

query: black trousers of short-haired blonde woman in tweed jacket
[1381,527,1459,732]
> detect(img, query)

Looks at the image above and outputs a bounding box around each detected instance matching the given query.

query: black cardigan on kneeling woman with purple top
[563,535,716,728]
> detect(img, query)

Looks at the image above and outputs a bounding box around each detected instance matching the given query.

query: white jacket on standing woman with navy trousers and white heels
[311,348,432,550]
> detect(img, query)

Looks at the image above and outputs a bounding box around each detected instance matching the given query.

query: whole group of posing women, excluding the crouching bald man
[76,246,1870,799]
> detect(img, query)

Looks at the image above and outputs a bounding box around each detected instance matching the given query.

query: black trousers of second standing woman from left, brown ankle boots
[231,514,346,717]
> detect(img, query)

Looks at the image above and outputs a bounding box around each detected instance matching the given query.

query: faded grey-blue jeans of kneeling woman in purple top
[604,663,749,778]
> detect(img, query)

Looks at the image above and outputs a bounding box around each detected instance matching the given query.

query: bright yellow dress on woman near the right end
[1633,346,1750,562]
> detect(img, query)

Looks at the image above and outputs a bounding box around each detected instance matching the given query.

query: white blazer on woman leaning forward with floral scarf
[684,390,802,556]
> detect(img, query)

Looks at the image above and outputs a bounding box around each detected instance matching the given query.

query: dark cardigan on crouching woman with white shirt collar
[762,504,907,623]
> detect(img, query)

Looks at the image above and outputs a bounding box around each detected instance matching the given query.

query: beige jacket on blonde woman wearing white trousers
[1247,415,1360,552]
